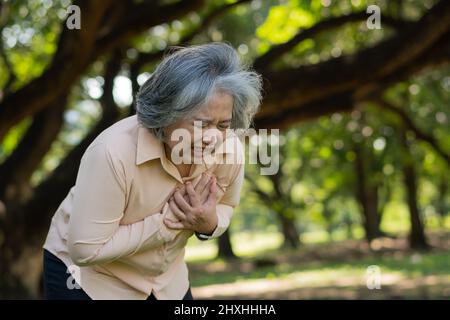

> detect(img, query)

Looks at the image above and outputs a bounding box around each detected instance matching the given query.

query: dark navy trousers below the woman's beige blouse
[44,249,193,300]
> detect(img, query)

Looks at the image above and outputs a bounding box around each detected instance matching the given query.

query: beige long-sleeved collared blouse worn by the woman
[43,116,244,300]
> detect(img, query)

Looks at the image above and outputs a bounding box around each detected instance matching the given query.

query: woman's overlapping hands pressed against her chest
[164,176,217,235]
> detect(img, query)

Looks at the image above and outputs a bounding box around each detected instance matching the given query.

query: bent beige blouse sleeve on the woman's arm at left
[68,143,179,265]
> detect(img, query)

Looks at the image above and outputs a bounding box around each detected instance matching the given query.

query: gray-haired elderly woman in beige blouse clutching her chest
[44,43,261,300]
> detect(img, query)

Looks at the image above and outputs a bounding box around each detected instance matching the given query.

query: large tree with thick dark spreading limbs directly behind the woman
[0,0,450,298]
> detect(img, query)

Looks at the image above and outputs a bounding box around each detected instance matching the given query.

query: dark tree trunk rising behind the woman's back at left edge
[0,56,124,298]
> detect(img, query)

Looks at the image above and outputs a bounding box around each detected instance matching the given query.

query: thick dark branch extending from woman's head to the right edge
[257,1,450,119]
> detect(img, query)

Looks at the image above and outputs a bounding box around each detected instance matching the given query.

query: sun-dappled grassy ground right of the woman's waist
[185,233,450,299]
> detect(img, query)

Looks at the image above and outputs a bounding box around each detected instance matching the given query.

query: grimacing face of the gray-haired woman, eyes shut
[165,91,233,164]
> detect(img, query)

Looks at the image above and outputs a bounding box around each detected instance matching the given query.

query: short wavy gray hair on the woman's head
[136,42,262,140]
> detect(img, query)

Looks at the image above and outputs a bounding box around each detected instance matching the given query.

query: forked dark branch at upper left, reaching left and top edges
[0,0,204,141]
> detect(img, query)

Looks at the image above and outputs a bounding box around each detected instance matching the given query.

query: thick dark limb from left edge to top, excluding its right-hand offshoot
[0,0,111,141]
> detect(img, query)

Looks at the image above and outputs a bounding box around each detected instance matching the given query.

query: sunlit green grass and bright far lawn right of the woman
[187,232,450,299]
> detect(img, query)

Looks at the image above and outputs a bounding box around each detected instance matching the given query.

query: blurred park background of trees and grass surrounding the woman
[0,0,450,299]
